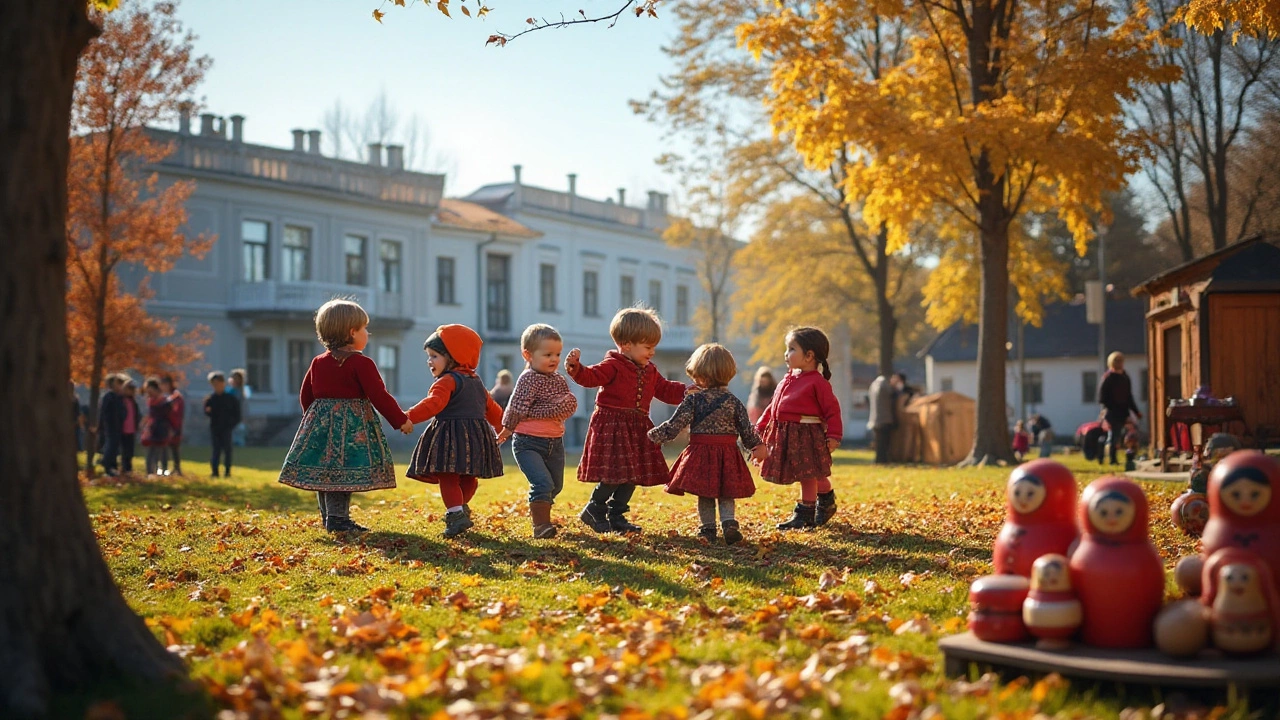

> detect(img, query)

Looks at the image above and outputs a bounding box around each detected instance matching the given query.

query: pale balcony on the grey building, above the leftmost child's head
[227,281,413,329]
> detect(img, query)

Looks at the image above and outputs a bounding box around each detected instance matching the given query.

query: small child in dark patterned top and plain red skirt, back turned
[649,343,764,544]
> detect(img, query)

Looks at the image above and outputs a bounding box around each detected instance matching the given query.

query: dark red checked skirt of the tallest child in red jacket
[577,405,671,487]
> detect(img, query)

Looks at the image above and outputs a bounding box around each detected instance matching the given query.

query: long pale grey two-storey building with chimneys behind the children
[135,114,727,443]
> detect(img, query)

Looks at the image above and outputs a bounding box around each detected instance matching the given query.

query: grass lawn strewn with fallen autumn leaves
[84,448,1228,719]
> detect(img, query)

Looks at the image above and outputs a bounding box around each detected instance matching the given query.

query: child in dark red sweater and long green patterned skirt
[280,300,413,533]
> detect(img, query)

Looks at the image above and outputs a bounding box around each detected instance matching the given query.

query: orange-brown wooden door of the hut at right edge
[1208,293,1280,432]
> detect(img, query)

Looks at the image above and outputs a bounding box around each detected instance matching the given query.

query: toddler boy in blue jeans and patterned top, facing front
[498,324,577,538]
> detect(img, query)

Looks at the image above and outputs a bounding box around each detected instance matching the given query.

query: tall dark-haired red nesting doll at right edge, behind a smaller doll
[1201,450,1280,578]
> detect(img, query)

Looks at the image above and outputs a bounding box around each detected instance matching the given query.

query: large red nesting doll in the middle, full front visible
[1070,478,1165,648]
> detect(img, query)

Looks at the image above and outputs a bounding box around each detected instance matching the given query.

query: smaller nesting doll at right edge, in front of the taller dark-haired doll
[1201,547,1280,655]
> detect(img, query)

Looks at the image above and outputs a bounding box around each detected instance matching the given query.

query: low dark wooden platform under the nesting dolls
[938,633,1280,693]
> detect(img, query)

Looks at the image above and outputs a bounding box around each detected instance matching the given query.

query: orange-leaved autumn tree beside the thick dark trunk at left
[67,3,212,473]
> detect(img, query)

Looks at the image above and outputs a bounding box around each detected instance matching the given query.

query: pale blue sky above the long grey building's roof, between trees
[178,0,691,198]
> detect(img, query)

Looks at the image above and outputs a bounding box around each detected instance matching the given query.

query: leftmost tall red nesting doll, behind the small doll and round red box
[992,460,1079,578]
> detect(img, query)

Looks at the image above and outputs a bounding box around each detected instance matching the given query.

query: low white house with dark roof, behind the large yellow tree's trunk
[919,299,1149,430]
